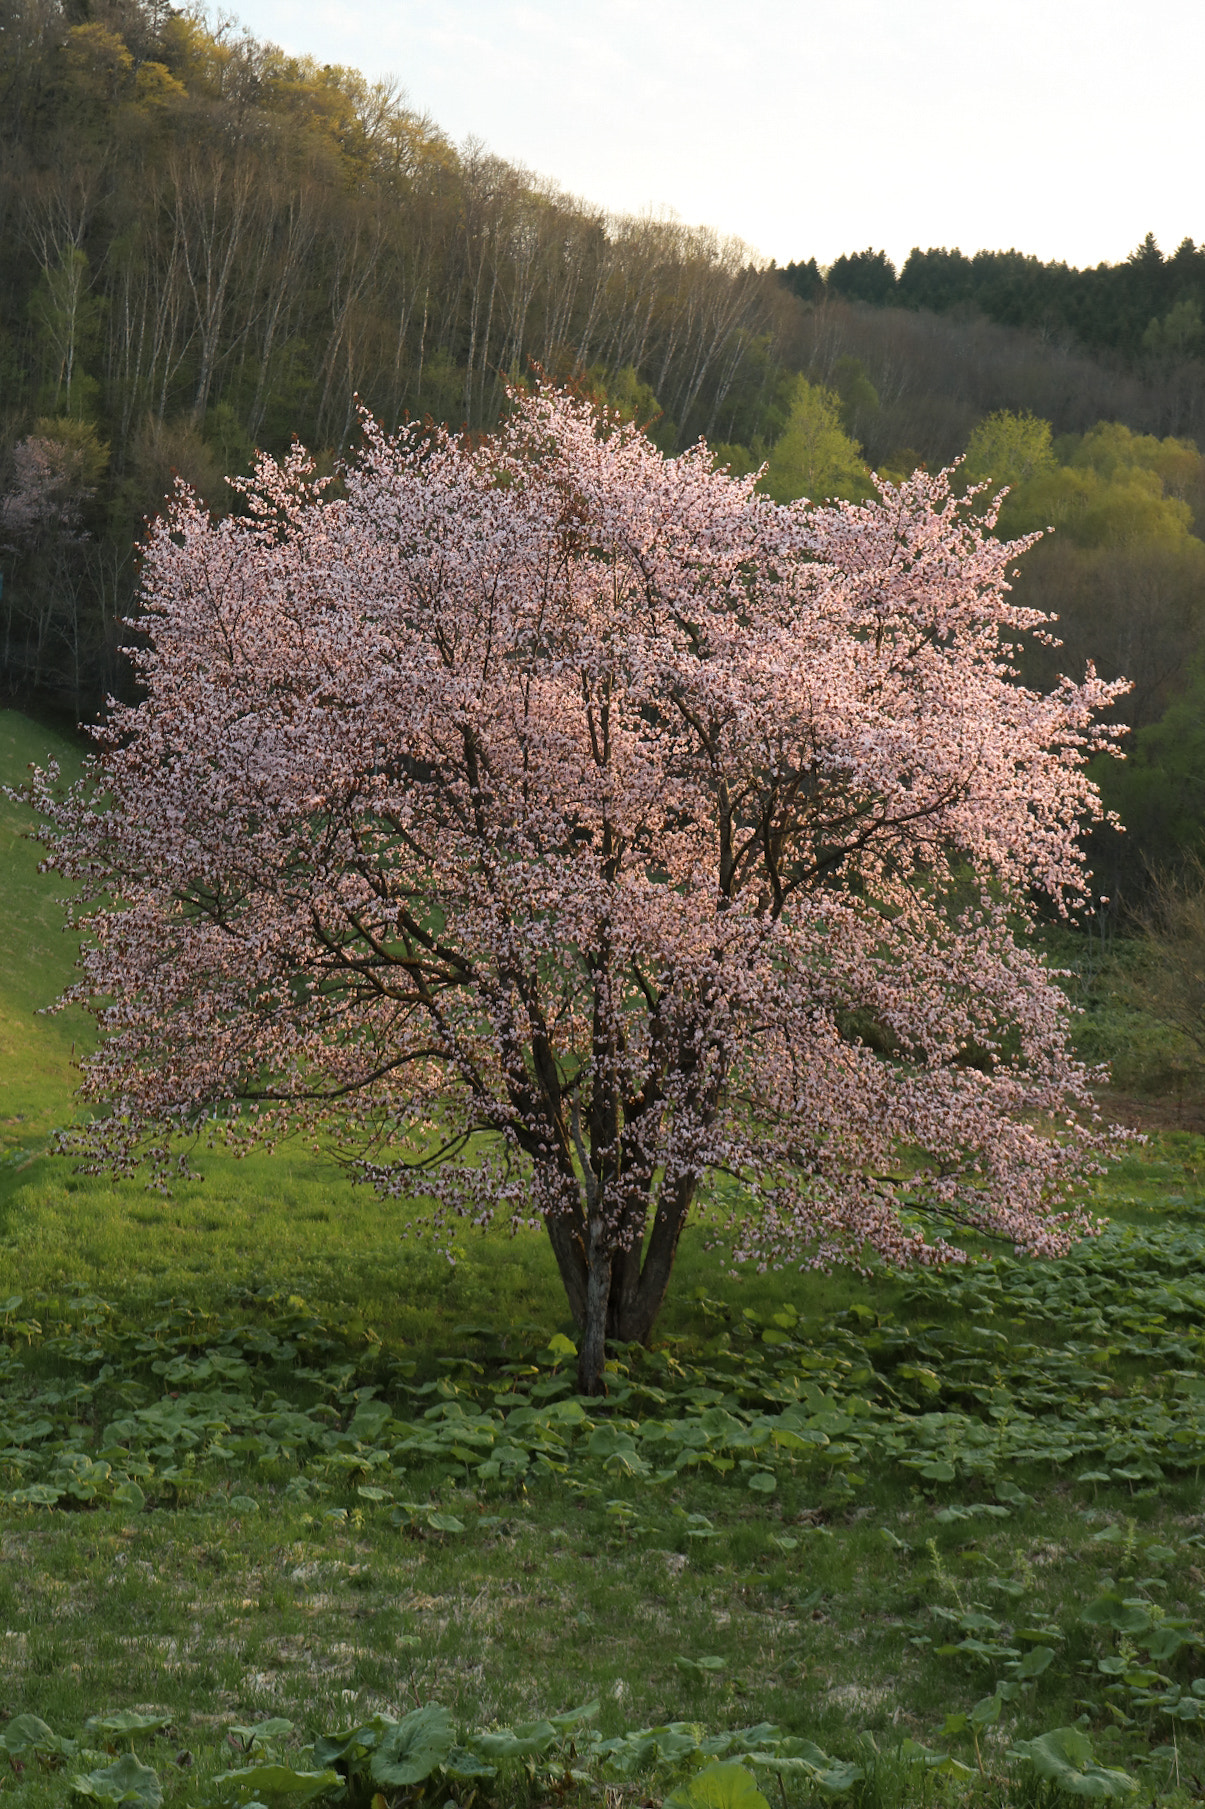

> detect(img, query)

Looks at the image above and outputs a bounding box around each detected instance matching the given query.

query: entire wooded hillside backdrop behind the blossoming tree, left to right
[0,0,1205,888]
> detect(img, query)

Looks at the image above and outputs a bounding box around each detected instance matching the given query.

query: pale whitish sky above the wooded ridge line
[222,0,1205,264]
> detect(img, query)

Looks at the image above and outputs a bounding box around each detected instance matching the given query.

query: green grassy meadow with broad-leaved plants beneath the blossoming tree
[0,713,1205,1809]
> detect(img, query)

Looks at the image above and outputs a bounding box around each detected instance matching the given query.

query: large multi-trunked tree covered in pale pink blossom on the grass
[36,387,1124,1389]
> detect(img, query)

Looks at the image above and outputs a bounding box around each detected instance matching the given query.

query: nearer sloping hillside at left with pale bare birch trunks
[0,0,796,707]
